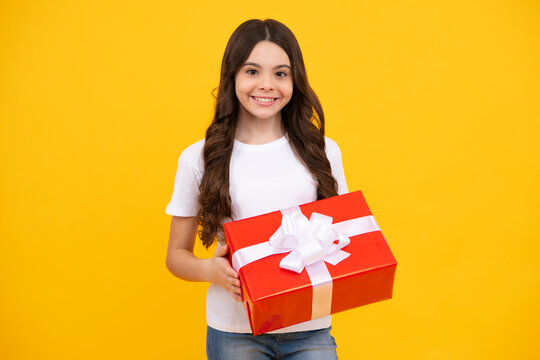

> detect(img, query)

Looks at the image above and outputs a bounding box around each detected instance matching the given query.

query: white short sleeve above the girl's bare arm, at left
[165,147,201,217]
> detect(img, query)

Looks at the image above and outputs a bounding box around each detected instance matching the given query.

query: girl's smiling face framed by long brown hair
[235,41,293,119]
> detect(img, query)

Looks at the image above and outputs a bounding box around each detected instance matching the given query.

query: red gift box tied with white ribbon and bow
[224,191,397,335]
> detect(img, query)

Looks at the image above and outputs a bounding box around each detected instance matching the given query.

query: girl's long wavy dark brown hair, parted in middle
[197,19,337,247]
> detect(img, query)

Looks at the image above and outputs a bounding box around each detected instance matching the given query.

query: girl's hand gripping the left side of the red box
[210,243,242,302]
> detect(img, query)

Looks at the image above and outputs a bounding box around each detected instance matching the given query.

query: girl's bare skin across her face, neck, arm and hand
[166,41,293,301]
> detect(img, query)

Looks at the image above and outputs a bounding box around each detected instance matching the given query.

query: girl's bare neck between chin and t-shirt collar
[235,108,285,145]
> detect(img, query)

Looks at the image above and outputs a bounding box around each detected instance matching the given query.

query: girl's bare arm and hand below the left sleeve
[166,216,242,301]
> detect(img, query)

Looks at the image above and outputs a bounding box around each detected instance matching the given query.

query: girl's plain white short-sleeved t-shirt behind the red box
[165,136,348,333]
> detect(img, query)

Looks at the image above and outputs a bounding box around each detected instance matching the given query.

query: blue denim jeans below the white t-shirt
[206,326,337,360]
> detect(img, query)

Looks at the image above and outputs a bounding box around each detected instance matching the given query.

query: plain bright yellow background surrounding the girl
[0,0,540,359]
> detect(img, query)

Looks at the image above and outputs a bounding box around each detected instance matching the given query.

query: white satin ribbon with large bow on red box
[232,206,380,319]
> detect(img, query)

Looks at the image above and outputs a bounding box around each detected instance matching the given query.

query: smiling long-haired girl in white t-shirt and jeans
[166,19,348,360]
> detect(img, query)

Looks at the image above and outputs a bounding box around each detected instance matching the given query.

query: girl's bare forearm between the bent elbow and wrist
[166,249,213,281]
